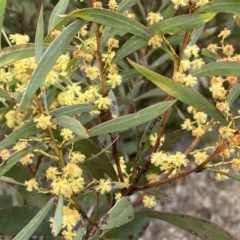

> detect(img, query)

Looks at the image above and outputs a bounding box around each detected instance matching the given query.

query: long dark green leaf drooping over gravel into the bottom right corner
[136,211,237,240]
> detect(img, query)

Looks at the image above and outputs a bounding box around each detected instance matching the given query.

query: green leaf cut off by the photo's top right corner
[197,0,240,14]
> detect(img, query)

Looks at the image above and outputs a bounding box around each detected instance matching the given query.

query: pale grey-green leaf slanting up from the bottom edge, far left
[14,199,54,240]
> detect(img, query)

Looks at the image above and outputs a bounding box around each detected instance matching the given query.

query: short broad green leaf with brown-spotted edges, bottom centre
[99,197,134,230]
